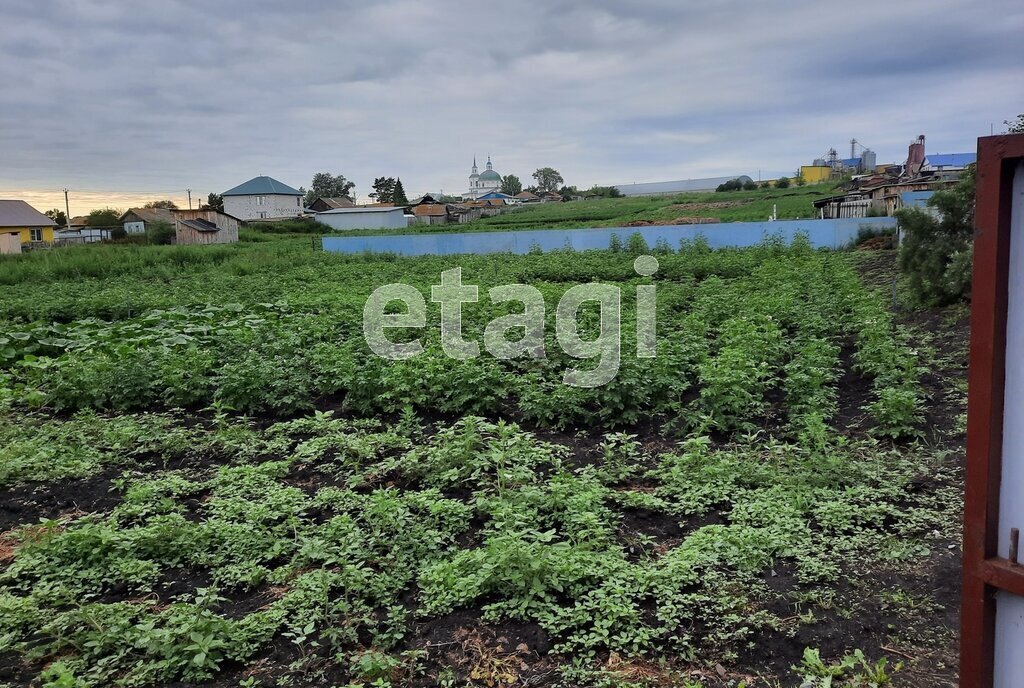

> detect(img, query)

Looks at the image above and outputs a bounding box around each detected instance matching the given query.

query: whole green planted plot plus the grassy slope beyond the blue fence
[0,237,963,688]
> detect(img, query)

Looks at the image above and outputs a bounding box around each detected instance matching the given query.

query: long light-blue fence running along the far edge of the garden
[324,217,896,256]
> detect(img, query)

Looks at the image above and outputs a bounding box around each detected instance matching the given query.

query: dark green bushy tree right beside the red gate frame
[896,165,975,306]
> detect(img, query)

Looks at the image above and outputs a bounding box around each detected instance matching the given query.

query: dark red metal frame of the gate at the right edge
[959,134,1024,688]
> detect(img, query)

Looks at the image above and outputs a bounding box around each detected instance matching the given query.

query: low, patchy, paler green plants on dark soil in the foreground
[0,413,944,686]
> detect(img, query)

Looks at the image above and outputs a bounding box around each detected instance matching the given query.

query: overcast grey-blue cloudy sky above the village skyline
[0,0,1024,214]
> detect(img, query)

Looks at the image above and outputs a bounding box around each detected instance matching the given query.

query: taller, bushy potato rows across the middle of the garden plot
[0,248,922,436]
